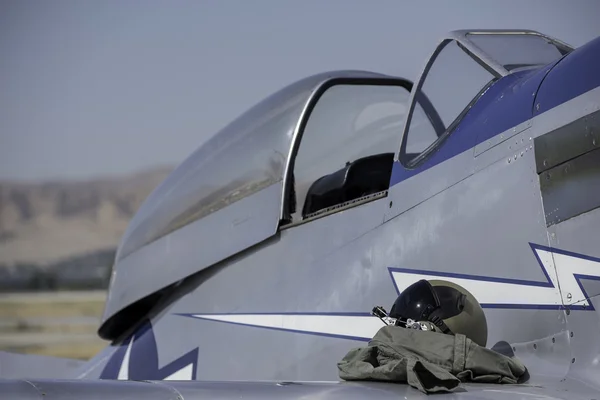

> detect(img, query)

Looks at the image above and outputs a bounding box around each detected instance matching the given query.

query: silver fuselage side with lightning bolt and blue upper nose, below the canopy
[80,35,600,394]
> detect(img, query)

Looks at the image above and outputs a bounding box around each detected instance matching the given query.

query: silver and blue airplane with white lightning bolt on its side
[0,29,600,400]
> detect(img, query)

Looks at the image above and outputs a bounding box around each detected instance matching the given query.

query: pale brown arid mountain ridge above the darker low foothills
[0,166,173,268]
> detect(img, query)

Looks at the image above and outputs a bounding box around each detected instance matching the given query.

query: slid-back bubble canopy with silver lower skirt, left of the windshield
[104,71,412,335]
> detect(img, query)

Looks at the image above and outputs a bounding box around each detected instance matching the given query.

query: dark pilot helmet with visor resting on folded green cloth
[390,279,487,347]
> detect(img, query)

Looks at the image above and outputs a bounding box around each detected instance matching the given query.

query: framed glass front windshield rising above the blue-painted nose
[400,30,572,165]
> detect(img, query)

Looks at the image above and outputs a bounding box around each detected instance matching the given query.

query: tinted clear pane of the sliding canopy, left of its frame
[117,76,322,259]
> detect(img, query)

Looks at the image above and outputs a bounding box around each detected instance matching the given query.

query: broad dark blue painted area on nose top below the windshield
[390,37,600,187]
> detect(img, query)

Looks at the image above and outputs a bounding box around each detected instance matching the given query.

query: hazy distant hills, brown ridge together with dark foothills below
[0,167,173,291]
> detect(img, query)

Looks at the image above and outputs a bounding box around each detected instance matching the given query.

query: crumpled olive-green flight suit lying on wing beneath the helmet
[338,326,529,393]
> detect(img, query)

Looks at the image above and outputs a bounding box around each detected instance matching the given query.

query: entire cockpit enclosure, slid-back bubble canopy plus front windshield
[103,31,572,337]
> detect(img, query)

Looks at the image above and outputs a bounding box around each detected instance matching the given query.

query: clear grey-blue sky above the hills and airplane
[0,0,600,181]
